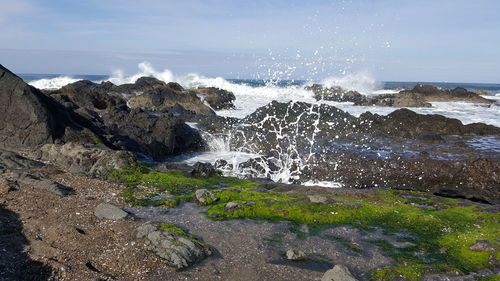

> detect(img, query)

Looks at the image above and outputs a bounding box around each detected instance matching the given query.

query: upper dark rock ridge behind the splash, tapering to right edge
[209,101,500,155]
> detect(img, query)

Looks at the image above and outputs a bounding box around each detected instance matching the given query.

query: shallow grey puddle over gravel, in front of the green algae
[126,203,394,280]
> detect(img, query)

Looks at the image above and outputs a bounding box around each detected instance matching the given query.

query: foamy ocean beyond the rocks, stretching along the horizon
[20,71,500,127]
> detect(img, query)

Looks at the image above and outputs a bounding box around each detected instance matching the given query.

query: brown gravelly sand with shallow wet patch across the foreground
[0,170,398,281]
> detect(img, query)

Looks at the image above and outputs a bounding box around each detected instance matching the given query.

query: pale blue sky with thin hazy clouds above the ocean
[0,0,500,83]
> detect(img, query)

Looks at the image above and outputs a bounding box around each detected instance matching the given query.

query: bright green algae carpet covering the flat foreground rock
[110,164,500,280]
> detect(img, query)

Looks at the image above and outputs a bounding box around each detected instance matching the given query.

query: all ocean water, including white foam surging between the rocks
[16,69,500,187]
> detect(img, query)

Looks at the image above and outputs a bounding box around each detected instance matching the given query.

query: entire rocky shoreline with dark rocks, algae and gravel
[0,66,500,281]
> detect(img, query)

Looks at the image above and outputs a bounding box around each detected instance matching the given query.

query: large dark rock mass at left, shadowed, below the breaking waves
[0,67,205,161]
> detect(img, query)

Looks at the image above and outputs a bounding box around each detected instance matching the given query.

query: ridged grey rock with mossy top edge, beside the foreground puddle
[137,223,212,269]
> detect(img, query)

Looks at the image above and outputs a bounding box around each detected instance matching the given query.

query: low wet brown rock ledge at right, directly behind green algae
[301,154,500,204]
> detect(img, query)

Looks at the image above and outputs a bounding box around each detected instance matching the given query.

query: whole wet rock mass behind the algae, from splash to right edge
[202,102,500,203]
